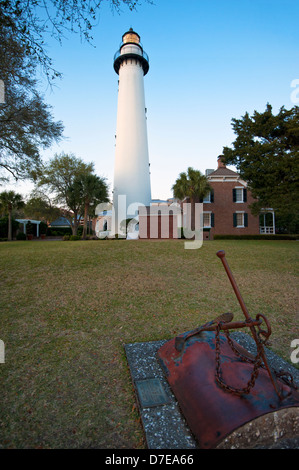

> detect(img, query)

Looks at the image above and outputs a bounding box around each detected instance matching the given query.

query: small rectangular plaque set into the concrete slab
[135,378,169,408]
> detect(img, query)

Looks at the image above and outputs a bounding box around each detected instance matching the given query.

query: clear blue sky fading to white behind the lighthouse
[5,0,299,199]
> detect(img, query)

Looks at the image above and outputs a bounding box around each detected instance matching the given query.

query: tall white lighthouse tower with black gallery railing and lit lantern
[113,28,151,233]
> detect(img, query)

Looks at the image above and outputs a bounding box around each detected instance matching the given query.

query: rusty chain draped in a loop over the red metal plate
[215,322,262,396]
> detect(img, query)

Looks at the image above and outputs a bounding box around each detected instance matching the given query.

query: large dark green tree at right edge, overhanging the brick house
[223,104,299,217]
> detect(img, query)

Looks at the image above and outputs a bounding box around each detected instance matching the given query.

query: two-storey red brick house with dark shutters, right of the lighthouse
[203,156,260,239]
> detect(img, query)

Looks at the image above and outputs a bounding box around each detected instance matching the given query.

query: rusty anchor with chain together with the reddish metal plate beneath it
[157,251,299,448]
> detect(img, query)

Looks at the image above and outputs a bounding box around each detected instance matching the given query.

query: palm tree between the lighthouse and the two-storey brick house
[172,167,211,230]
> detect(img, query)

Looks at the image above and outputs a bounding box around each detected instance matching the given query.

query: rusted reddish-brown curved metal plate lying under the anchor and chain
[157,331,299,449]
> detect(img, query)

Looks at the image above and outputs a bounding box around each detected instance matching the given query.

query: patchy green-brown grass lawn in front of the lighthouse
[0,240,299,449]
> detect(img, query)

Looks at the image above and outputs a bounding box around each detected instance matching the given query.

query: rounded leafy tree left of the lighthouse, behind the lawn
[38,152,93,235]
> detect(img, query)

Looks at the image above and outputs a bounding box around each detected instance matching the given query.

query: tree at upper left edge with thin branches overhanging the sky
[0,0,151,181]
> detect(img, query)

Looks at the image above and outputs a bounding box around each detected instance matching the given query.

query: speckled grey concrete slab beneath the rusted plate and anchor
[125,332,299,449]
